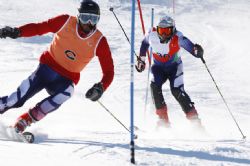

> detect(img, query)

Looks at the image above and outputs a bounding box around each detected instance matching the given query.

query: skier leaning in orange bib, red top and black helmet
[0,0,114,133]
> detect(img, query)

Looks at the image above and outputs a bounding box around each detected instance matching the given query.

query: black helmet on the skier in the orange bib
[78,0,100,15]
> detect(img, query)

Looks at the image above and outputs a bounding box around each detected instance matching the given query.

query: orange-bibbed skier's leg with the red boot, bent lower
[14,81,74,132]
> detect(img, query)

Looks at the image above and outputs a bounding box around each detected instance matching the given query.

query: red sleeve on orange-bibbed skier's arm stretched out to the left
[19,14,69,37]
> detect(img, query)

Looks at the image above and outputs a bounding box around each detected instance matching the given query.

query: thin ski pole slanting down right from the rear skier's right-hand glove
[201,57,246,139]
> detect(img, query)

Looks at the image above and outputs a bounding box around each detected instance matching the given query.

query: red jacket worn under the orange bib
[19,15,114,90]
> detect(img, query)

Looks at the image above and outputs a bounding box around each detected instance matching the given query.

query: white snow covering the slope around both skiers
[0,0,250,166]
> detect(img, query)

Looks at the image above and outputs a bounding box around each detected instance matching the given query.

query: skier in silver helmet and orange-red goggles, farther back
[136,16,203,126]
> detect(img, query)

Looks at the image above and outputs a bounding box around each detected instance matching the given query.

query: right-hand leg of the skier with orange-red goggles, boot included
[169,63,198,119]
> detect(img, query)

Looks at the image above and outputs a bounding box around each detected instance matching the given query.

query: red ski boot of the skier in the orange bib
[13,112,33,133]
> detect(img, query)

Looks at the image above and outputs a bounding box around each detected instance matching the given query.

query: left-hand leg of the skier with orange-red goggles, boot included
[150,65,169,123]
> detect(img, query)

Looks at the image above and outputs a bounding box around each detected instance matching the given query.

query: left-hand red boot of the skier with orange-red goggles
[156,106,170,127]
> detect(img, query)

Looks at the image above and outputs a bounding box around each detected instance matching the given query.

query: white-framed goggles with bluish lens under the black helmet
[77,13,100,25]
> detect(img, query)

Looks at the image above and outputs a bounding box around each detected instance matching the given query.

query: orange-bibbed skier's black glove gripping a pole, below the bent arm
[85,82,104,101]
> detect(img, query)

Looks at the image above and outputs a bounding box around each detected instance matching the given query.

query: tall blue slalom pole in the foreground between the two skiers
[130,0,135,164]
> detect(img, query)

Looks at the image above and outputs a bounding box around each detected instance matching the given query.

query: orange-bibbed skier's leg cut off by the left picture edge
[0,65,47,114]
